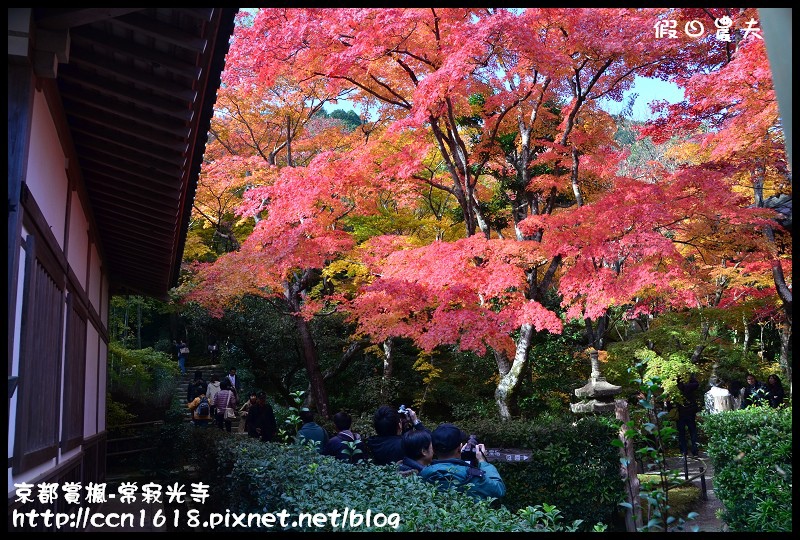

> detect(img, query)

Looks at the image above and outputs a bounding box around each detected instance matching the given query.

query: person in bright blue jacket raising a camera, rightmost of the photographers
[419,424,506,499]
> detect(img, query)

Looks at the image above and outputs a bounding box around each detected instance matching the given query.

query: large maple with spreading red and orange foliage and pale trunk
[183,8,788,418]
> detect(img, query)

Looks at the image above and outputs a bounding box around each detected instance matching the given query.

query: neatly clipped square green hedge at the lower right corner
[702,407,792,532]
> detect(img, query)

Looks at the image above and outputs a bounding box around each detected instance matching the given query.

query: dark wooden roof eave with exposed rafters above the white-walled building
[34,8,237,298]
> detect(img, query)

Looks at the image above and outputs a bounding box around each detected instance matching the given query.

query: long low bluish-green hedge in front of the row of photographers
[189,437,602,532]
